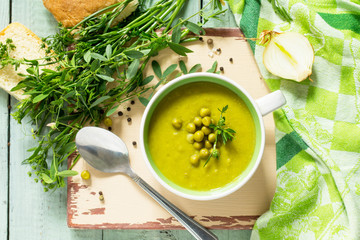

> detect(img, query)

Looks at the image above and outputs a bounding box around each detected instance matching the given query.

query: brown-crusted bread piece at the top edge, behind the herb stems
[43,0,138,27]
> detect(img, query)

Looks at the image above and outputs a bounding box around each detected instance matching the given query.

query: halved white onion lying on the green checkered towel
[260,31,315,82]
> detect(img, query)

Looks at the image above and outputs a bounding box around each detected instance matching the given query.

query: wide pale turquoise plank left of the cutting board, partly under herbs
[9,0,102,240]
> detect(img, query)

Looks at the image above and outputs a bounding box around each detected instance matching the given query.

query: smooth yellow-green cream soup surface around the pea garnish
[148,82,255,191]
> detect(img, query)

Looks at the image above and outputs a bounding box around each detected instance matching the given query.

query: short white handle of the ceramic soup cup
[256,90,286,116]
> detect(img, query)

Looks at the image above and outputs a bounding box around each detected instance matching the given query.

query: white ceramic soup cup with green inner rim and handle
[140,73,285,200]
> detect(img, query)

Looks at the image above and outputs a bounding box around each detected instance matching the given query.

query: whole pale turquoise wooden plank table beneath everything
[0,0,251,240]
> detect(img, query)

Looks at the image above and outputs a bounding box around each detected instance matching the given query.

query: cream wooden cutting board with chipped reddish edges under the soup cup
[67,29,276,229]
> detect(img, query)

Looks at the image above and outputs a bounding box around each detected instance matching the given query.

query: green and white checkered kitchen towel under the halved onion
[228,0,360,240]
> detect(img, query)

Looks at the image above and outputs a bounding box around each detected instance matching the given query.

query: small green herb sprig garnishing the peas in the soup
[204,105,236,167]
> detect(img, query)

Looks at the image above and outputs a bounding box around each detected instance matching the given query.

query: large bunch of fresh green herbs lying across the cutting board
[0,0,224,191]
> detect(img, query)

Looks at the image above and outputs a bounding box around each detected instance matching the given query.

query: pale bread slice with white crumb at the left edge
[0,23,45,100]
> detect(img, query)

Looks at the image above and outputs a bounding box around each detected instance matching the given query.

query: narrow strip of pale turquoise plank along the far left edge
[0,1,10,239]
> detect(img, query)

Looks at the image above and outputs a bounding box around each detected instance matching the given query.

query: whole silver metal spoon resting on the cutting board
[75,127,218,240]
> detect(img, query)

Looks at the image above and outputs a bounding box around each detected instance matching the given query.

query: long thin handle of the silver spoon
[131,174,218,240]
